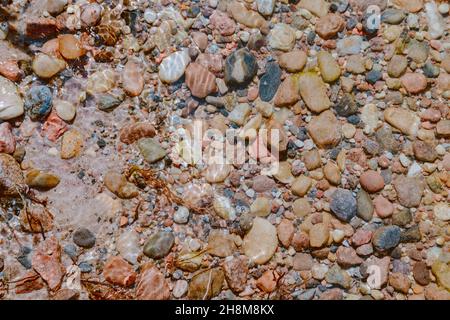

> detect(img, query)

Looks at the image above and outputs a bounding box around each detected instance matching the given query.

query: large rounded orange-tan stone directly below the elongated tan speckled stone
[307,110,341,148]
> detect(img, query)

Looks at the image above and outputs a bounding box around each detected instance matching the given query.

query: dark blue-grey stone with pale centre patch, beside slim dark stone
[225,48,258,85]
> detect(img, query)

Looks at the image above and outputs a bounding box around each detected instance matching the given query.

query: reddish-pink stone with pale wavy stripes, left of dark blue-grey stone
[186,63,217,98]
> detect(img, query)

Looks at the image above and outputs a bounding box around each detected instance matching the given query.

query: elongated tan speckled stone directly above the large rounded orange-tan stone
[298,72,331,113]
